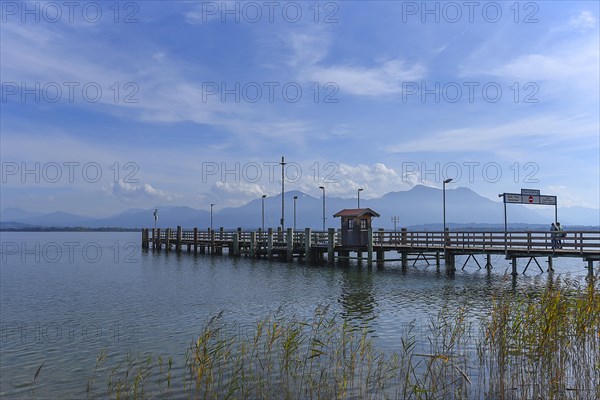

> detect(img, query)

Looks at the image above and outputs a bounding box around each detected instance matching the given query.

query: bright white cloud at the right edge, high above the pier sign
[461,12,600,104]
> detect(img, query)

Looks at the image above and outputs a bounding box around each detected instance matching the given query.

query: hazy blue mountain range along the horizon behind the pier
[0,185,600,230]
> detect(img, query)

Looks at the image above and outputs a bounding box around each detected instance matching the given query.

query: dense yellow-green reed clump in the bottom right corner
[478,280,600,399]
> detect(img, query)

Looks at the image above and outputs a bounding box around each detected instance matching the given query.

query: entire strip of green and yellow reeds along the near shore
[87,281,600,399]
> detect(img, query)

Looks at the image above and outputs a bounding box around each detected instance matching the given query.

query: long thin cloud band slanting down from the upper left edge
[1,18,308,142]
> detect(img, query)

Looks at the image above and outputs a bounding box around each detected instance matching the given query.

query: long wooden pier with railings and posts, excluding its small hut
[142,227,600,276]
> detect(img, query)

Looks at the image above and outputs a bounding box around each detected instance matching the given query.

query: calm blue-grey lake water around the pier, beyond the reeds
[0,232,597,399]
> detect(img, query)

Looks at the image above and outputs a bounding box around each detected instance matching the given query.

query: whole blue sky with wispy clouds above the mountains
[0,1,600,216]
